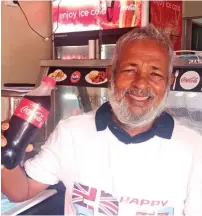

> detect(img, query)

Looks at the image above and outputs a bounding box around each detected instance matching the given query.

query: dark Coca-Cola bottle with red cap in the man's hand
[1,76,55,169]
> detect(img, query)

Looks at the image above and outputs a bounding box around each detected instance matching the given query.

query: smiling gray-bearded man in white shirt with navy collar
[2,25,202,216]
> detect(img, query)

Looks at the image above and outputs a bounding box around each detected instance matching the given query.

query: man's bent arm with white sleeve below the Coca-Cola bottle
[1,123,61,202]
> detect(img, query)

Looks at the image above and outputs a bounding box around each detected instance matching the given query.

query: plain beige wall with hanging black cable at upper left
[1,1,52,84]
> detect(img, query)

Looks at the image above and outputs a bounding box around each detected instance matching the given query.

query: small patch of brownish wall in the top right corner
[183,1,202,17]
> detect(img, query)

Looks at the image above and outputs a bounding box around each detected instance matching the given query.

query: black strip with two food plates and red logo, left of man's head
[48,67,108,88]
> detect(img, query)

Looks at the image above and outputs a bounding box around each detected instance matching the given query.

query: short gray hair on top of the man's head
[112,24,174,79]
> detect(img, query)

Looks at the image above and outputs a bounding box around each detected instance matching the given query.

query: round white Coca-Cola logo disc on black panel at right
[180,71,200,90]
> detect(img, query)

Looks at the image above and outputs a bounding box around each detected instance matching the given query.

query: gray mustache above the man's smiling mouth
[122,88,156,99]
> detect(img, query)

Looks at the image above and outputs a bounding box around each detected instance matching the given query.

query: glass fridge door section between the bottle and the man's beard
[47,86,107,134]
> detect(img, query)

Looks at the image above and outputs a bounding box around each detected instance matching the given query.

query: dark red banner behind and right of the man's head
[150,1,182,50]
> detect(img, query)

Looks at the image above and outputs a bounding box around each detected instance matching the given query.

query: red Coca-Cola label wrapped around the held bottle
[14,98,49,128]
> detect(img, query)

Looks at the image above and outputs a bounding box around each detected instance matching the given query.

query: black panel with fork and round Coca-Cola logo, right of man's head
[171,67,202,92]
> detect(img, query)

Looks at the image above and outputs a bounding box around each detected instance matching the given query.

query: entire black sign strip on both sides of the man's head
[48,66,202,92]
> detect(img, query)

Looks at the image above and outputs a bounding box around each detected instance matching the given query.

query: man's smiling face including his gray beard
[109,40,169,128]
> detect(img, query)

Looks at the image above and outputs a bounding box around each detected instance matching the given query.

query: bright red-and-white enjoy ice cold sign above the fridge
[52,0,142,33]
